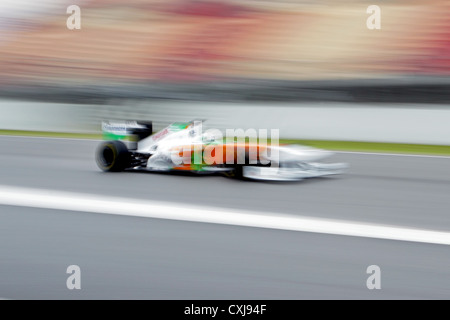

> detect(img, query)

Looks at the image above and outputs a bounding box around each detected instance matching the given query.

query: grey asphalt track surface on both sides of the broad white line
[0,137,450,300]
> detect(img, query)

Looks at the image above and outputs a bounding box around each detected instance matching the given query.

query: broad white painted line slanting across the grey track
[0,185,450,245]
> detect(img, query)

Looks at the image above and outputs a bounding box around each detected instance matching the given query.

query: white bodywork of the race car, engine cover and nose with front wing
[137,122,348,181]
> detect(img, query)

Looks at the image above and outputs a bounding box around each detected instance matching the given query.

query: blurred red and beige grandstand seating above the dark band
[0,0,450,86]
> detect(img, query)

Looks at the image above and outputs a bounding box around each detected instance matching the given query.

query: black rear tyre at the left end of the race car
[95,140,130,172]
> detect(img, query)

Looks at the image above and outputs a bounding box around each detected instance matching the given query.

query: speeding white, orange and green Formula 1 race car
[96,120,347,181]
